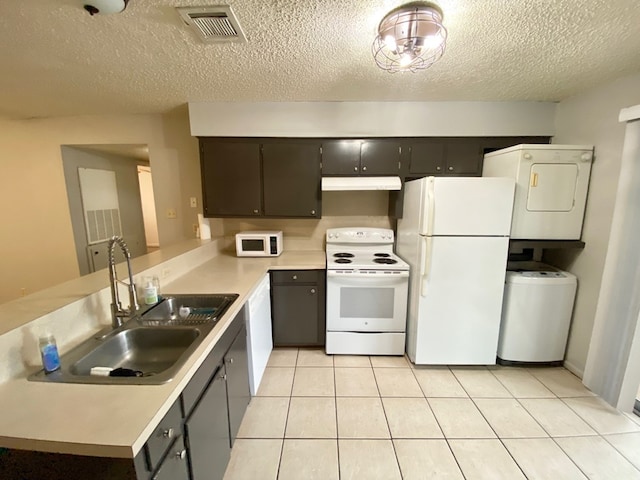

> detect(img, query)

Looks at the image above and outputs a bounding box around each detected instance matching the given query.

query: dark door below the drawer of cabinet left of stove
[271,285,325,347]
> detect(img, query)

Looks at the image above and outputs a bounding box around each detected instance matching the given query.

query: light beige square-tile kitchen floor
[225,349,640,480]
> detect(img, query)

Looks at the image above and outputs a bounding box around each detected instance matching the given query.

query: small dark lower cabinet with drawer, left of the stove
[271,270,326,347]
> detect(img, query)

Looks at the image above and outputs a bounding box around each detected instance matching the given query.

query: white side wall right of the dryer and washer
[545,74,640,376]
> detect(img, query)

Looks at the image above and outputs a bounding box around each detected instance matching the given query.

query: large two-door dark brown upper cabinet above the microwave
[200,138,321,218]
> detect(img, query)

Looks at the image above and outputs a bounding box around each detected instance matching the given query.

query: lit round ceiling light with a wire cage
[372,2,447,73]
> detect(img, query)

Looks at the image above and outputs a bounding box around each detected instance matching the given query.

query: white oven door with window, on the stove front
[327,270,409,332]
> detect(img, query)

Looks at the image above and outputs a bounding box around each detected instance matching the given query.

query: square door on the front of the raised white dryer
[527,163,578,212]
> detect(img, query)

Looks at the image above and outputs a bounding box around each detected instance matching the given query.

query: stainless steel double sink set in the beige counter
[29,294,238,385]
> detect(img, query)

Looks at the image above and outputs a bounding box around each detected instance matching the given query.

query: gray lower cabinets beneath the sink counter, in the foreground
[135,307,251,480]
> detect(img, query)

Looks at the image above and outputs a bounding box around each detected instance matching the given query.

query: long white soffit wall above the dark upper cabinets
[189,102,556,138]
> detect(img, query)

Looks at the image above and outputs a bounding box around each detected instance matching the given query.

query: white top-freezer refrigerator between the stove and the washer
[396,177,515,365]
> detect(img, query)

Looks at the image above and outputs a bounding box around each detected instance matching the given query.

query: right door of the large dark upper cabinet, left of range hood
[262,143,320,218]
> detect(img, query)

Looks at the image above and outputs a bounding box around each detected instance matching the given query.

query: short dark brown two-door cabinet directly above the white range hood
[322,139,401,176]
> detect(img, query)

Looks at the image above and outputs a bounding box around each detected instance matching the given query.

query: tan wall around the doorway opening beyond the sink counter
[0,108,222,303]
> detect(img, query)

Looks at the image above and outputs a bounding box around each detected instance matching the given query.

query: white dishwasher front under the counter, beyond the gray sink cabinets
[247,274,273,396]
